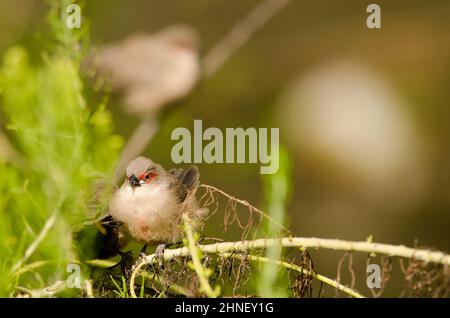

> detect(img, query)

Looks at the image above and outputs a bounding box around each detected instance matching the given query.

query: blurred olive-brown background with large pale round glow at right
[0,0,450,295]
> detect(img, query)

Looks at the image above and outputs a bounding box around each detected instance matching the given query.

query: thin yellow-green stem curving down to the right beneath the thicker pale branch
[221,253,365,298]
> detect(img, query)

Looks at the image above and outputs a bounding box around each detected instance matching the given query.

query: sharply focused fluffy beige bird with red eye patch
[101,156,208,257]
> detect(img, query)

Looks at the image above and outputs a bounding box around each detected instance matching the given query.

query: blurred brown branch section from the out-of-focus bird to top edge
[203,0,290,78]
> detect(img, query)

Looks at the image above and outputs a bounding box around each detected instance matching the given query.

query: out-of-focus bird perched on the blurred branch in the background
[94,24,200,115]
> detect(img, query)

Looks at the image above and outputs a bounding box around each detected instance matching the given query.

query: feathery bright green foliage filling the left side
[0,1,122,296]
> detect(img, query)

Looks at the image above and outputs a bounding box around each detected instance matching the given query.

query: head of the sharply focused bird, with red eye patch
[125,156,164,189]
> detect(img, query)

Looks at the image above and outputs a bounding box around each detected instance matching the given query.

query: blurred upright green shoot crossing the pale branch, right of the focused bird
[256,147,293,297]
